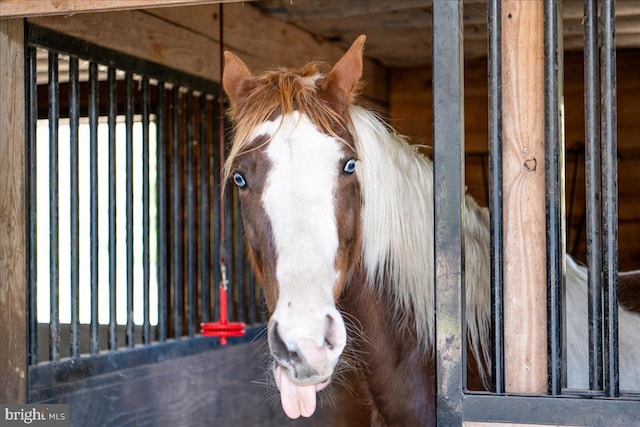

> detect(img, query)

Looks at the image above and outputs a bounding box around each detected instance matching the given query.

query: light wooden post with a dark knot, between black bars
[502,0,547,393]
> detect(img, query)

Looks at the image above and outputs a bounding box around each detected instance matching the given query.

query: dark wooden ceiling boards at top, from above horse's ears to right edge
[252,0,640,68]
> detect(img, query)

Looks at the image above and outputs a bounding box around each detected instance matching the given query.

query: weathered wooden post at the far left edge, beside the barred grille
[0,19,27,403]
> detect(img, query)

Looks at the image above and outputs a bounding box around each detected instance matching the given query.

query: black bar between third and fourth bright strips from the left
[89,62,100,354]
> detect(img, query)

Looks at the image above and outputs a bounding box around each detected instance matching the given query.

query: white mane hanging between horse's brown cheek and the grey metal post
[350,107,434,351]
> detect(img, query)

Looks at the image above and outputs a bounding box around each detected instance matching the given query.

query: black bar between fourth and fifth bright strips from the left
[107,65,118,350]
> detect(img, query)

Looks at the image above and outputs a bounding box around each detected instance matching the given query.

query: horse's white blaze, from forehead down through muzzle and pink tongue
[256,112,346,418]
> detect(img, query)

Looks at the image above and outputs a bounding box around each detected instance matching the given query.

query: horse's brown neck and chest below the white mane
[339,265,435,426]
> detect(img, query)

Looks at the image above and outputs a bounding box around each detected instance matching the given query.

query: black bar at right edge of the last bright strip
[156,82,168,342]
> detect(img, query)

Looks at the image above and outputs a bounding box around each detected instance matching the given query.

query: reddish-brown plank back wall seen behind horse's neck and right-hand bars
[389,50,640,270]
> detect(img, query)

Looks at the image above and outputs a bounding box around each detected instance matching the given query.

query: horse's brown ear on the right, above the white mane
[323,34,367,102]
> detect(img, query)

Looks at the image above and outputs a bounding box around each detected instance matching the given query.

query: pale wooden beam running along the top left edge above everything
[0,0,242,19]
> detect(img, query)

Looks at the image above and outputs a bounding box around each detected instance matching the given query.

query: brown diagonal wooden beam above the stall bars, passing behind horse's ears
[29,4,389,107]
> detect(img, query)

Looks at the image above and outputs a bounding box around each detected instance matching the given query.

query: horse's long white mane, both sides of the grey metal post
[350,106,490,374]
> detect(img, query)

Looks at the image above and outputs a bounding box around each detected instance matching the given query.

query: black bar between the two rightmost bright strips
[142,76,151,344]
